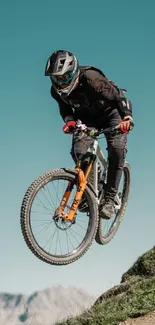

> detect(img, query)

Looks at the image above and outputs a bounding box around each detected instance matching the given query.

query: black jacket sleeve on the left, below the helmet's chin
[51,87,74,121]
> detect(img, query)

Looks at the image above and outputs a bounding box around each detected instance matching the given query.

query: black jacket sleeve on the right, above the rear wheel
[87,70,132,118]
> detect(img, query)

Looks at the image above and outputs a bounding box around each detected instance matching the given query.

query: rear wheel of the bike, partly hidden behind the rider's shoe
[95,163,131,245]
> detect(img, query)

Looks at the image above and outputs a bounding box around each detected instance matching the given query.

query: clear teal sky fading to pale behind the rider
[0,0,155,295]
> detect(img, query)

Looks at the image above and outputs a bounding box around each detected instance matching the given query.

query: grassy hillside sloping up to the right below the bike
[57,247,155,325]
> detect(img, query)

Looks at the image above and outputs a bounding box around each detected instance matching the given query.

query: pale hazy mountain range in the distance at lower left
[0,286,96,325]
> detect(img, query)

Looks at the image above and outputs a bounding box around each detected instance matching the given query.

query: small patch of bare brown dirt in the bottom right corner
[119,311,155,325]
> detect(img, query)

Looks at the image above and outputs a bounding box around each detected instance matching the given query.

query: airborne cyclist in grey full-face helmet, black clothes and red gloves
[45,50,134,219]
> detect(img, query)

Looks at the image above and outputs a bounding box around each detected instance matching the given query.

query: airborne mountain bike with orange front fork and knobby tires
[20,126,131,265]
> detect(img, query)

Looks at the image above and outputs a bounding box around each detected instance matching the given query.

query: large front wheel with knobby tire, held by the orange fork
[20,169,98,265]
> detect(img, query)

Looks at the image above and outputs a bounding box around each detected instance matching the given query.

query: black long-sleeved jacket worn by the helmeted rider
[51,67,132,127]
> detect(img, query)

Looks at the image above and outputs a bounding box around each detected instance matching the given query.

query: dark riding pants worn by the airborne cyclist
[71,109,127,198]
